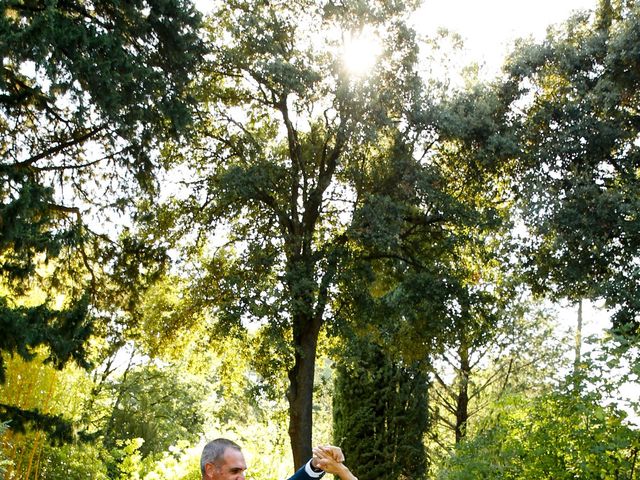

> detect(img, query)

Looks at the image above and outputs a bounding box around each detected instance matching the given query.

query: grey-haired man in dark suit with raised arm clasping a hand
[200,438,355,480]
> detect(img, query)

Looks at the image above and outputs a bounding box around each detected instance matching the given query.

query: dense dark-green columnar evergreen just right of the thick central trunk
[333,339,428,480]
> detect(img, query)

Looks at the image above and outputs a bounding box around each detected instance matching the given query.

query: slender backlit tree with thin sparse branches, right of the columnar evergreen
[429,297,561,458]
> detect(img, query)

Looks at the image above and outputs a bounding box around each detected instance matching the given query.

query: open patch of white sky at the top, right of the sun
[415,0,597,76]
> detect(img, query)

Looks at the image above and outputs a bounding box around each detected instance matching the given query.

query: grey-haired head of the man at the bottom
[200,438,247,480]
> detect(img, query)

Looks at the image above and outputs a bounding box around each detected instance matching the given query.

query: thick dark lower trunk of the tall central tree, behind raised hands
[287,316,321,470]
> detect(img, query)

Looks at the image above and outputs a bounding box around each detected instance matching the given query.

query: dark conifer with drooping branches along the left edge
[0,0,202,438]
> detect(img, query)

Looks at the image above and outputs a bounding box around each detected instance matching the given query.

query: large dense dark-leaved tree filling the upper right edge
[505,0,640,332]
